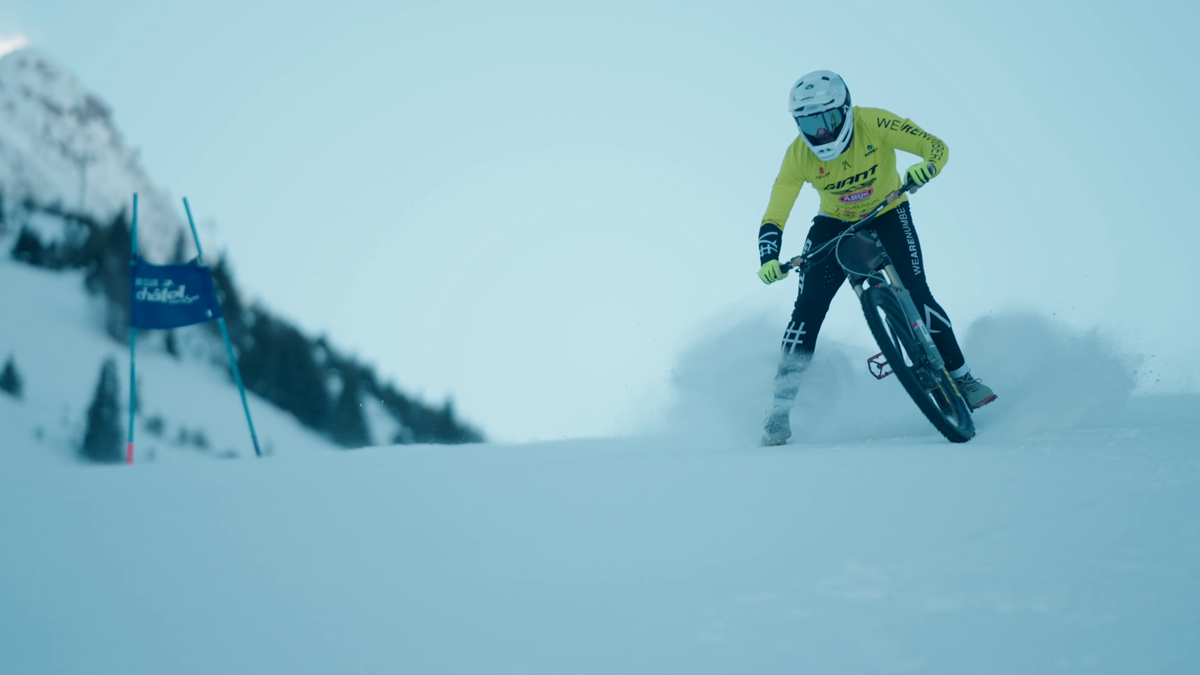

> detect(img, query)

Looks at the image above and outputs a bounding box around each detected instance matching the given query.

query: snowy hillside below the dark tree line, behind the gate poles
[0,249,336,466]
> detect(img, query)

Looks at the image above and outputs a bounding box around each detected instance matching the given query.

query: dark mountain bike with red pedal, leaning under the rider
[780,181,976,443]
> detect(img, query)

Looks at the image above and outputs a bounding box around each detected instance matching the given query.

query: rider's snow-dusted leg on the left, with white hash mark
[773,216,846,411]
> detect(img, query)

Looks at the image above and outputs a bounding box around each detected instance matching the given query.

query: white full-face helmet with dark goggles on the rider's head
[787,71,854,162]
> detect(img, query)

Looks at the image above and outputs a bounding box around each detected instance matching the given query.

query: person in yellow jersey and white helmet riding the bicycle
[758,71,996,444]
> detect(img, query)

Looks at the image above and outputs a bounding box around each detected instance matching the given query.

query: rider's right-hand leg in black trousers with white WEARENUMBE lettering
[872,202,971,377]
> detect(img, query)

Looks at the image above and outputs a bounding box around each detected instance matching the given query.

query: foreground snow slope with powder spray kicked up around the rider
[0,297,1200,675]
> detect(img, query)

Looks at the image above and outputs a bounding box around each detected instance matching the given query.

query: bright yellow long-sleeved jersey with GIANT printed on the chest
[761,107,950,229]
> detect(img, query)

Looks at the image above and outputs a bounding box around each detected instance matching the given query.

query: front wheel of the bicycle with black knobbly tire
[863,286,974,443]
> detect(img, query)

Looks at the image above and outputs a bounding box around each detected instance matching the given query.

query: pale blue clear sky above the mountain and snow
[0,0,1200,440]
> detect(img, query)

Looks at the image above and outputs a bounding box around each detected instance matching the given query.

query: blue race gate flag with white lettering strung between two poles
[130,257,221,329]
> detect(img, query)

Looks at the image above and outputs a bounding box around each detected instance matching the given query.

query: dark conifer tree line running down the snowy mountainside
[0,196,484,456]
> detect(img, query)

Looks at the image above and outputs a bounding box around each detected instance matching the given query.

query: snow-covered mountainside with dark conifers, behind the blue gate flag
[0,49,481,456]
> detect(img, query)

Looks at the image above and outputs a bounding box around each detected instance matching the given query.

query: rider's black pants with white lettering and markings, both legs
[775,202,966,404]
